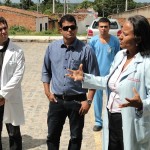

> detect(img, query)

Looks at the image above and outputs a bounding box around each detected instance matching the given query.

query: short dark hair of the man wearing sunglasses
[59,14,77,28]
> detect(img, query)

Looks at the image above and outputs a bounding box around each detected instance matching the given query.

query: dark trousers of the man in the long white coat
[0,106,22,150]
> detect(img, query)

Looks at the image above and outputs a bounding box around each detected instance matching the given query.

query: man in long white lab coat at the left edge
[0,17,25,150]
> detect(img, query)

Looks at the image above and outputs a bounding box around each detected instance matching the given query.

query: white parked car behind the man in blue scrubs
[86,18,121,42]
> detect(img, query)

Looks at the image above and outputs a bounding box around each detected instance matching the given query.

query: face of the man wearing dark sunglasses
[60,21,77,42]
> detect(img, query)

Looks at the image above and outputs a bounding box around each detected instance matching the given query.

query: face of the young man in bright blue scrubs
[98,22,110,35]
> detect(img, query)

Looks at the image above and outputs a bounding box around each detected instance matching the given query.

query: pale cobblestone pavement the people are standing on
[2,42,102,150]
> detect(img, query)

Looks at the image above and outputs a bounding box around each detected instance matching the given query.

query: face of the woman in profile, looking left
[119,21,137,52]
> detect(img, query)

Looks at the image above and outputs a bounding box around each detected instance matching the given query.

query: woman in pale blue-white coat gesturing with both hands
[67,15,150,150]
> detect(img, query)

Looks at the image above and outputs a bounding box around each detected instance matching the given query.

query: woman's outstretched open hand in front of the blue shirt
[66,64,84,81]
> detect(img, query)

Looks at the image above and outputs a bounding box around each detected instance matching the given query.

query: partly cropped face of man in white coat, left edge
[0,22,8,45]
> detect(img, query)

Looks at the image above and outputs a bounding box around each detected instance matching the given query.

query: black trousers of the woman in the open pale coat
[108,112,124,150]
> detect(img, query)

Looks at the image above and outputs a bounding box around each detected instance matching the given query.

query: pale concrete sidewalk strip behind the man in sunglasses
[9,35,86,43]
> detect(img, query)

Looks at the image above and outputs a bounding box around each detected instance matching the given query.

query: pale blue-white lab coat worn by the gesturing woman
[83,50,150,150]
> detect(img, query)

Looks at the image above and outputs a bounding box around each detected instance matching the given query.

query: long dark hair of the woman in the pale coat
[128,15,150,56]
